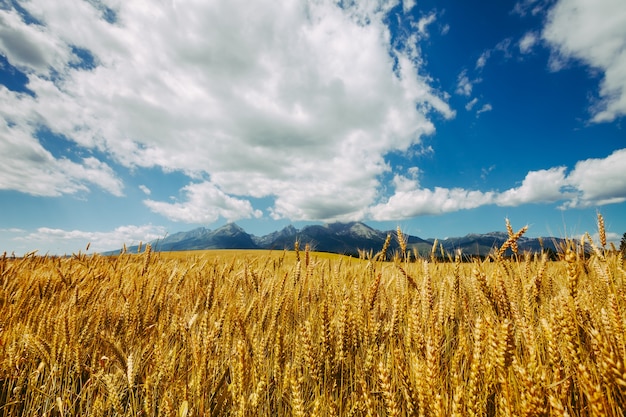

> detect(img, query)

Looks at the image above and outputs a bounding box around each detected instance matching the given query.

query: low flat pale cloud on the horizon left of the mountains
[15,225,166,250]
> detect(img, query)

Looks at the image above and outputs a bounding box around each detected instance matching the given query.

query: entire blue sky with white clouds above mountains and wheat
[0,0,626,254]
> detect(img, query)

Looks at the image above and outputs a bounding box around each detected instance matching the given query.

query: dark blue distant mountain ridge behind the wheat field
[105,222,563,256]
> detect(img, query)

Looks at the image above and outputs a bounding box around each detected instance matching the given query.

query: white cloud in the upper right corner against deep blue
[541,0,626,122]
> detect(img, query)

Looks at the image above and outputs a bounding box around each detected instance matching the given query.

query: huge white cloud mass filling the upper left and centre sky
[0,0,454,222]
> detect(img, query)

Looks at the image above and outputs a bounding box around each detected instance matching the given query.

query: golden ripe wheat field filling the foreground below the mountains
[0,219,626,417]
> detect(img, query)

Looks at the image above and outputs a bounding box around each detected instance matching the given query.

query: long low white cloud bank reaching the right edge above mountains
[369,149,626,220]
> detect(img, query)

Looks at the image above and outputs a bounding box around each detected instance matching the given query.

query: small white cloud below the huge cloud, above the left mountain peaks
[144,181,261,223]
